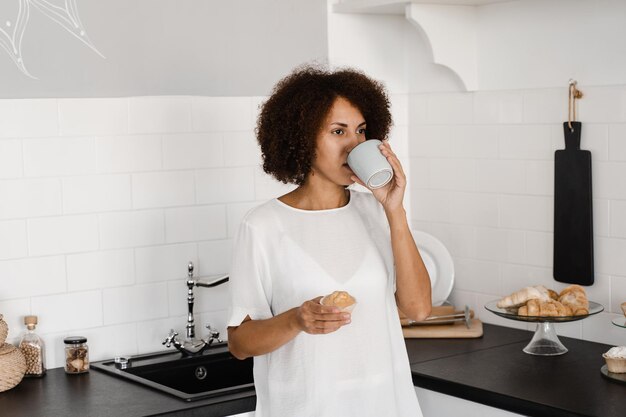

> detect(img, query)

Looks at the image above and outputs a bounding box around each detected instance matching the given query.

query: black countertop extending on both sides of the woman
[0,324,626,417]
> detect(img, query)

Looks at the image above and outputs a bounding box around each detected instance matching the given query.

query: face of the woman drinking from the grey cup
[313,97,365,186]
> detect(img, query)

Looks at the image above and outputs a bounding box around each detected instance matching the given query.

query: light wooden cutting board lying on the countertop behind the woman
[398,306,483,339]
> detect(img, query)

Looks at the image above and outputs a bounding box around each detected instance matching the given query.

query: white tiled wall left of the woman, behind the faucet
[0,96,298,367]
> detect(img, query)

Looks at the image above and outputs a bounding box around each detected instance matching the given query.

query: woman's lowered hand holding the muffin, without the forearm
[296,297,351,334]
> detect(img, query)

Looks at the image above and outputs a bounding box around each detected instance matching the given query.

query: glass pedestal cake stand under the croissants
[485,300,604,356]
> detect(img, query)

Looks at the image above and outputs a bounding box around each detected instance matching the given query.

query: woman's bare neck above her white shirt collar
[279,181,350,210]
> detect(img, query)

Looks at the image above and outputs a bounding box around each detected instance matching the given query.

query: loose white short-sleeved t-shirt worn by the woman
[227,190,422,417]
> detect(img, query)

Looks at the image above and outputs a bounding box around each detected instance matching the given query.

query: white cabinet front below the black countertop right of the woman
[415,387,521,417]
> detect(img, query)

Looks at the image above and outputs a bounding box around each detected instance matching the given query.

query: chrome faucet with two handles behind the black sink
[163,261,228,356]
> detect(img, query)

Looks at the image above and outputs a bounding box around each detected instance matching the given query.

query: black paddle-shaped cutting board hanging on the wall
[553,122,593,285]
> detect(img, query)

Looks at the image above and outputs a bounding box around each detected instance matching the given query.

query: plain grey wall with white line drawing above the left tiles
[0,0,327,98]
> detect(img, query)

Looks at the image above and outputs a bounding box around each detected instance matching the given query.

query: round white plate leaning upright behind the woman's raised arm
[411,230,454,306]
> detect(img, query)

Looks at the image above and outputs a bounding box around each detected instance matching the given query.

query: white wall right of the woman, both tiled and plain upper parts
[328,0,626,345]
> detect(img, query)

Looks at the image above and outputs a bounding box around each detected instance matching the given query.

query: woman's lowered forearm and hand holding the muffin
[228,297,350,359]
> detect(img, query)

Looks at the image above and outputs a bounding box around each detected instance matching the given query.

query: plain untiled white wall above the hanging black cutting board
[477,0,626,90]
